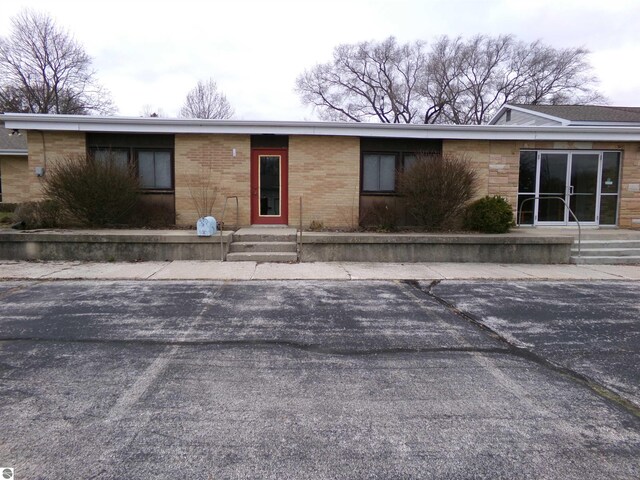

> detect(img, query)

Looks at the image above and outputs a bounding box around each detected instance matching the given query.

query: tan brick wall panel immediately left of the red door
[175,134,251,225]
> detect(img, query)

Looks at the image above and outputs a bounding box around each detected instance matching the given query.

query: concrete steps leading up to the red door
[227,228,298,263]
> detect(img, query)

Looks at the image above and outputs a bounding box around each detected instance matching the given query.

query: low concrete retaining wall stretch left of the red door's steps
[0,230,232,262]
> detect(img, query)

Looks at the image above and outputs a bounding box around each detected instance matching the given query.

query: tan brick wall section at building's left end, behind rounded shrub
[27,131,87,200]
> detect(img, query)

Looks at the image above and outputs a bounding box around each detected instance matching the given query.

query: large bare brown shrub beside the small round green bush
[398,153,477,230]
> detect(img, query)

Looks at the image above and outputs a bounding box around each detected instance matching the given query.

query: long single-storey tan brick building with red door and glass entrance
[0,105,640,228]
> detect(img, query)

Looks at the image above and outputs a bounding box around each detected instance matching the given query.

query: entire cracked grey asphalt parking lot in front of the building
[0,281,640,479]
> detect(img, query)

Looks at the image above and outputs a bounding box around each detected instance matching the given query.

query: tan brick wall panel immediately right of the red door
[289,136,360,228]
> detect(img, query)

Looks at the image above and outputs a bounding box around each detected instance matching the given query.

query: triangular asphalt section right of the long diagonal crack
[426,281,640,407]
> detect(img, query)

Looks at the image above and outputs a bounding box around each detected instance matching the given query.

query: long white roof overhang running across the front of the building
[0,113,640,142]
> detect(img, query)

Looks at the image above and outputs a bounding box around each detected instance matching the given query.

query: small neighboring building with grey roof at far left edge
[0,123,29,203]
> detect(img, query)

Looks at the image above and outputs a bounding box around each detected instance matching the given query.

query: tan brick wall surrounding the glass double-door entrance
[442,140,640,228]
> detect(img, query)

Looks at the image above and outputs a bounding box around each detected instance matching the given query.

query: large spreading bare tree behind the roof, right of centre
[296,35,604,124]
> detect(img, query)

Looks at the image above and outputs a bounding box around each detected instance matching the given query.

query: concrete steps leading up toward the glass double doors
[571,239,640,265]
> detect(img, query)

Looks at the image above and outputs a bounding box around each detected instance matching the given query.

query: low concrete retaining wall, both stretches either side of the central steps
[0,230,573,264]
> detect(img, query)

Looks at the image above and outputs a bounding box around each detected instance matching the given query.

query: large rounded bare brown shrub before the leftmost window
[43,156,140,226]
